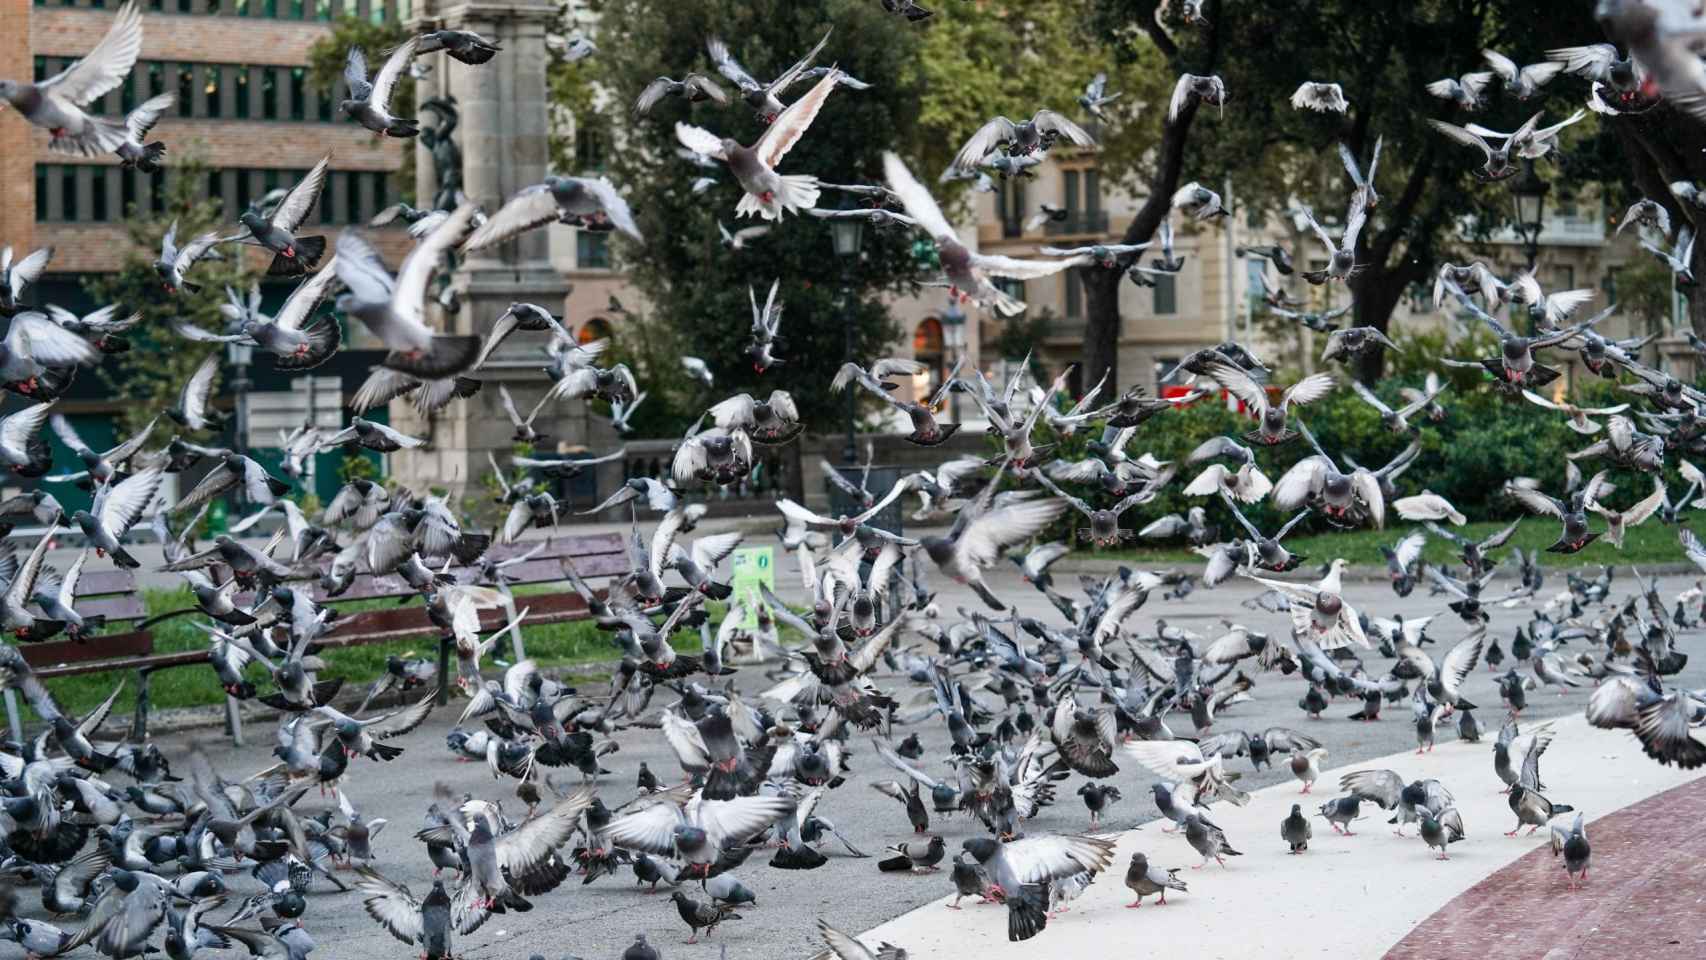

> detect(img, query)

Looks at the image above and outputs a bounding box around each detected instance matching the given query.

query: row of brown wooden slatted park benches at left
[5,534,630,747]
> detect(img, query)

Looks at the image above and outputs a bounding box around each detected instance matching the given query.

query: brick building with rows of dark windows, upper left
[0,0,408,506]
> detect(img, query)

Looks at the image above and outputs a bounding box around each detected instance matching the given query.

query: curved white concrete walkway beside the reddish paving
[853,716,1706,960]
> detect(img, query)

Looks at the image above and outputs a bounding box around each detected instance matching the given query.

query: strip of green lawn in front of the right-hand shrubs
[1097,517,1687,568]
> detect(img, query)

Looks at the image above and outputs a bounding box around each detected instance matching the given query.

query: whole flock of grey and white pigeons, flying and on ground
[0,0,1706,960]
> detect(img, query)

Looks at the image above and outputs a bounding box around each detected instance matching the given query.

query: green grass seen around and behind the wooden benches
[20,587,665,720]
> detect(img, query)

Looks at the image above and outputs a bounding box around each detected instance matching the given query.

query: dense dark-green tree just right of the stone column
[569,0,921,426]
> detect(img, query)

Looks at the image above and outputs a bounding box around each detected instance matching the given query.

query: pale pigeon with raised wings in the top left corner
[0,3,142,157]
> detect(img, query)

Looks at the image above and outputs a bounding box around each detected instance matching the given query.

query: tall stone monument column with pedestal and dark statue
[391,0,587,508]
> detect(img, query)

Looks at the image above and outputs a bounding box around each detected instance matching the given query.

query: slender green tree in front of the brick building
[84,152,249,440]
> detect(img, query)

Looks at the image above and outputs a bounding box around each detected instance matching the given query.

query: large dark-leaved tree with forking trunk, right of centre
[1083,0,1614,380]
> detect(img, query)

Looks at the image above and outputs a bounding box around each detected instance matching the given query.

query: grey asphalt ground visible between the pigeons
[7,568,1706,960]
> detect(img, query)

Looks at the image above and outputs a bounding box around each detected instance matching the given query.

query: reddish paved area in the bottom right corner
[1385,779,1706,960]
